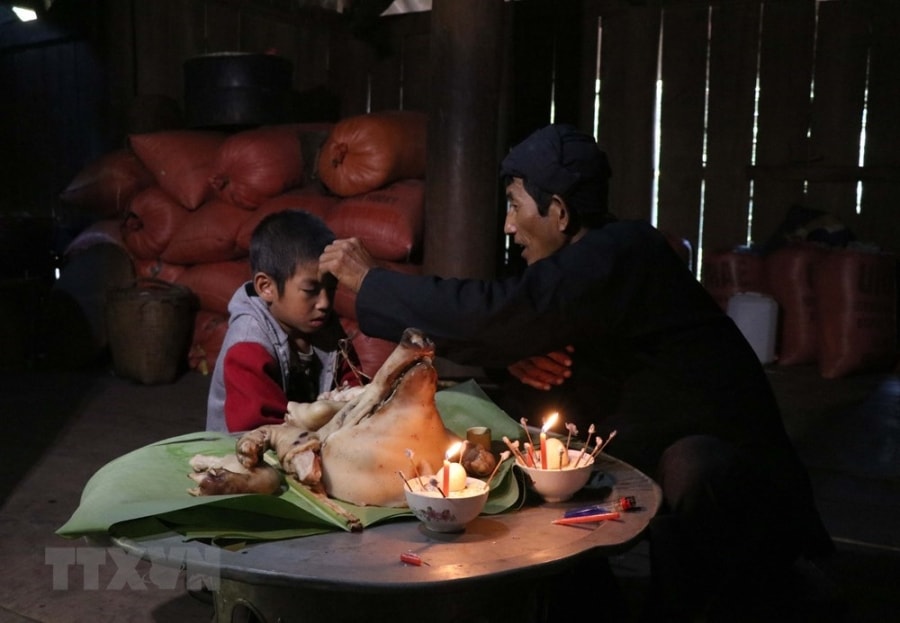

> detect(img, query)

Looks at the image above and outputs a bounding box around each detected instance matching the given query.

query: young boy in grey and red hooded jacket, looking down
[206,210,361,432]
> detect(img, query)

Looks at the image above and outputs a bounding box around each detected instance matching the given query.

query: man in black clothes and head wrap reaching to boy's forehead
[320,125,832,620]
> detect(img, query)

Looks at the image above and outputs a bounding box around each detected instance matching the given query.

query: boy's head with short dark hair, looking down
[250,210,336,335]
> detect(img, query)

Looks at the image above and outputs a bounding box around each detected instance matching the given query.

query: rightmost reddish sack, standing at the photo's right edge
[814,249,897,379]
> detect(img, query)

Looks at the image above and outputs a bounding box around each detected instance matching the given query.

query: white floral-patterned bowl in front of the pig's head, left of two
[403,477,490,532]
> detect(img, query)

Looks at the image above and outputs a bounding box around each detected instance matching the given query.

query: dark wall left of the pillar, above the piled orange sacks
[0,0,431,226]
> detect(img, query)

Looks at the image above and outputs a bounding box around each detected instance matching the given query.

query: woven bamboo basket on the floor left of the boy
[106,278,196,385]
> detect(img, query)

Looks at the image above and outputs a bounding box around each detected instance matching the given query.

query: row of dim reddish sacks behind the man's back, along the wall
[702,240,898,379]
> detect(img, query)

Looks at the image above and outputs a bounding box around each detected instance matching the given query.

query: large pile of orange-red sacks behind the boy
[61,111,426,375]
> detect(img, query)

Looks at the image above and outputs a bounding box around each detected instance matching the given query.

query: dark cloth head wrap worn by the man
[500,124,612,227]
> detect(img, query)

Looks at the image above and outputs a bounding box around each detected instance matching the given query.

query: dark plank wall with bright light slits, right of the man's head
[581,0,900,270]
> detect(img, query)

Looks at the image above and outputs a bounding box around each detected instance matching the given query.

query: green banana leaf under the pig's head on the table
[57,381,524,542]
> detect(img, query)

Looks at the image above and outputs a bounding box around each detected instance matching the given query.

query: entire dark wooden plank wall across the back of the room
[0,0,900,266]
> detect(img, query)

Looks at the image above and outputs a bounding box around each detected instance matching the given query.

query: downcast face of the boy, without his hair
[257,260,336,335]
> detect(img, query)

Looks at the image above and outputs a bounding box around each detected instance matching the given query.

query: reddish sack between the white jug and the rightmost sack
[765,243,825,366]
